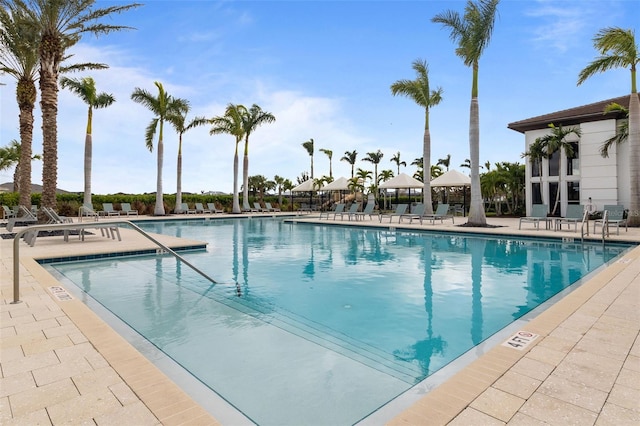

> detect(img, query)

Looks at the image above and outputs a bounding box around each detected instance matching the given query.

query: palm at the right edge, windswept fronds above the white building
[578,27,640,226]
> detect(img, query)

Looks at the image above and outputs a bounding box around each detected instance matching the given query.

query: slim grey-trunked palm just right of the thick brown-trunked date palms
[60,77,116,205]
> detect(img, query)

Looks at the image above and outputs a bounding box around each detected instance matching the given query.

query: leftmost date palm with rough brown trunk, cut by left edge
[0,3,39,208]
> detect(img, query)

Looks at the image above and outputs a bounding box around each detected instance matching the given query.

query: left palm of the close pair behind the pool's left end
[131,81,188,216]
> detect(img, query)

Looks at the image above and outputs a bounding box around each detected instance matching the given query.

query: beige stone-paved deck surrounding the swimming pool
[0,214,640,426]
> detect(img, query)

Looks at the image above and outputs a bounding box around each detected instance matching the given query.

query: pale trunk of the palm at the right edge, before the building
[627,92,640,227]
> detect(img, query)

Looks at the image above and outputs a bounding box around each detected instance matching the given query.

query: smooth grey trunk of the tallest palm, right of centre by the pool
[467,97,487,226]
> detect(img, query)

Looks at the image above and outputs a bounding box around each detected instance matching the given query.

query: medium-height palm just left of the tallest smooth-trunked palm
[391,60,442,214]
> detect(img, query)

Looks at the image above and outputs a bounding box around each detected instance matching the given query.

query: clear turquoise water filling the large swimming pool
[46,218,626,425]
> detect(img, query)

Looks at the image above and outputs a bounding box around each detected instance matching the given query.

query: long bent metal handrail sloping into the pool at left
[11,220,219,303]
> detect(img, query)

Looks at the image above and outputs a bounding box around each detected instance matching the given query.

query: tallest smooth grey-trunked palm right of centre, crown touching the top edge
[432,0,500,226]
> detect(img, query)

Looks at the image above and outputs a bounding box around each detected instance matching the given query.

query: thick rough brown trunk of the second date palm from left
[40,52,58,209]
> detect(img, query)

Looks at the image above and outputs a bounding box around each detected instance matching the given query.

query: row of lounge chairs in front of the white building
[518,204,628,234]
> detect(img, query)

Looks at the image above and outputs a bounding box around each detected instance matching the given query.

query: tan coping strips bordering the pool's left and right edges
[3,215,640,424]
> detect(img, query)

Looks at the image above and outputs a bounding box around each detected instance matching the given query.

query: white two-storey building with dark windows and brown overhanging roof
[508,95,631,216]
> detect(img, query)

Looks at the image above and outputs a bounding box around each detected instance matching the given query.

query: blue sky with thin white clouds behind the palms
[0,0,640,194]
